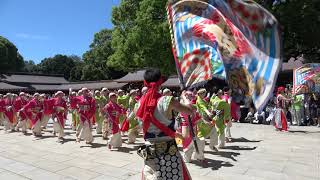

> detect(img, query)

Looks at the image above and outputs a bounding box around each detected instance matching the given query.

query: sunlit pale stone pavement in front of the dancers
[0,117,320,180]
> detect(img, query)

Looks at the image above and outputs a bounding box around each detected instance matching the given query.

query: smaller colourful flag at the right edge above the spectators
[293,63,320,94]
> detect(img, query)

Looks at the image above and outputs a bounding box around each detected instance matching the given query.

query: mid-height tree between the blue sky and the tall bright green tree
[81,29,123,80]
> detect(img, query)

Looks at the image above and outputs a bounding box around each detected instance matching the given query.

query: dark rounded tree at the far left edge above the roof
[0,36,24,72]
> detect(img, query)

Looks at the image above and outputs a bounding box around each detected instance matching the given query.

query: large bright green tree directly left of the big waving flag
[108,0,175,74]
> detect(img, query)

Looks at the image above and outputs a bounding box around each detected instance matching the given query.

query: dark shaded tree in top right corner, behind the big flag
[258,0,320,62]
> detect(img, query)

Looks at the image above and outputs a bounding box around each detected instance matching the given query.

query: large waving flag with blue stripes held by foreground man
[167,0,281,109]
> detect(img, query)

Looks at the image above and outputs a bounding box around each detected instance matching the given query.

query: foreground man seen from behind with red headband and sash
[136,69,192,180]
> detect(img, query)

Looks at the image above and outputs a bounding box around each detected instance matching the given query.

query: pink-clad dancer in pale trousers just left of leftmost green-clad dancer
[53,91,67,142]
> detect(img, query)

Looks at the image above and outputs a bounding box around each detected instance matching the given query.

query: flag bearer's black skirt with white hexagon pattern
[142,141,191,180]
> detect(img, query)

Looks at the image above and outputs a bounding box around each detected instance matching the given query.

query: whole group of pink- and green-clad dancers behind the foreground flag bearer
[0,84,236,164]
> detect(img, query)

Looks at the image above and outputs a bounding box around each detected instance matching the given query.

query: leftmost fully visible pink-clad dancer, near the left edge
[4,93,15,132]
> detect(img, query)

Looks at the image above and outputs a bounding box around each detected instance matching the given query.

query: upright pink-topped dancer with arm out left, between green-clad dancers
[70,88,96,144]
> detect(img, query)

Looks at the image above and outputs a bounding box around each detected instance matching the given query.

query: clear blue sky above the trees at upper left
[0,0,120,63]
